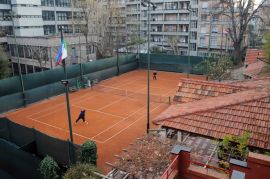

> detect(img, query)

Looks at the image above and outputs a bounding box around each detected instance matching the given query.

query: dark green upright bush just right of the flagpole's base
[80,140,97,165]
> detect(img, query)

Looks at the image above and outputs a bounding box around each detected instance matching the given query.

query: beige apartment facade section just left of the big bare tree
[197,0,232,56]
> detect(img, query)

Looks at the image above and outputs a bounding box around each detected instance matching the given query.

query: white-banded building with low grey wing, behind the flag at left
[0,0,97,74]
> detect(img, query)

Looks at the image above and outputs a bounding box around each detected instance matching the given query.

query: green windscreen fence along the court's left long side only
[0,54,138,113]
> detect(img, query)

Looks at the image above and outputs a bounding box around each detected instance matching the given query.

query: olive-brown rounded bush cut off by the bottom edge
[63,163,101,179]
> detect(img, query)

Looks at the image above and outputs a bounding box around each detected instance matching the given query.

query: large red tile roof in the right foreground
[154,80,270,149]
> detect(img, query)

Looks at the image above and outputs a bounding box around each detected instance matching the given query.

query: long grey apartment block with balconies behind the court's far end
[126,0,235,56]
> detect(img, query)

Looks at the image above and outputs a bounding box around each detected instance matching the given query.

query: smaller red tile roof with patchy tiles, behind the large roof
[174,78,247,103]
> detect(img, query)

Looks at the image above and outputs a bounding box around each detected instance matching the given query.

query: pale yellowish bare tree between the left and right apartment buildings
[73,0,121,58]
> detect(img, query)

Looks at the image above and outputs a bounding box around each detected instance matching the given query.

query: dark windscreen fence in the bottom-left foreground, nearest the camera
[0,118,80,178]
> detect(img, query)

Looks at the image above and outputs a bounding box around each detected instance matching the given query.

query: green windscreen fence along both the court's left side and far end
[0,54,205,113]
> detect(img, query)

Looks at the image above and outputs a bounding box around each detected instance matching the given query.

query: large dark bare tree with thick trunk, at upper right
[219,0,266,64]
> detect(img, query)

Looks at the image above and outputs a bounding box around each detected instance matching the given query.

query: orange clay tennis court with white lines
[6,70,204,172]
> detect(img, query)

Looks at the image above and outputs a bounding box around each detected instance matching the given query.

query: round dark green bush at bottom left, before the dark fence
[39,156,59,179]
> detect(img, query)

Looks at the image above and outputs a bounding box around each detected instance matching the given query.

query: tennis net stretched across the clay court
[93,85,171,104]
